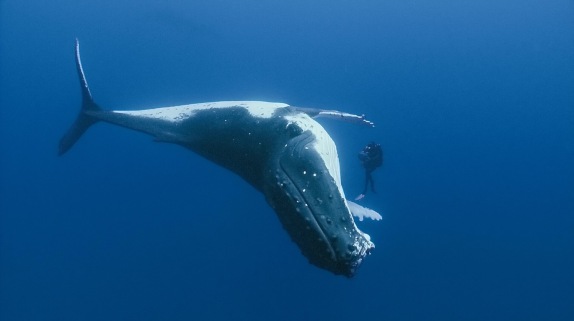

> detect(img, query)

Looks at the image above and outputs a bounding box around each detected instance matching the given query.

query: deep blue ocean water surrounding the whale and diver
[0,0,574,321]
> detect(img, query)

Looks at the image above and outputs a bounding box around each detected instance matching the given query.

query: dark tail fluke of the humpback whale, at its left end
[58,39,100,155]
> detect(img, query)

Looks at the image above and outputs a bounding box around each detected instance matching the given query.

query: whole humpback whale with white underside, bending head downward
[59,39,381,278]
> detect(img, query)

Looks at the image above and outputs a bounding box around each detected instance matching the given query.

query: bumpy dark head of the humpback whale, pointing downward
[263,114,374,277]
